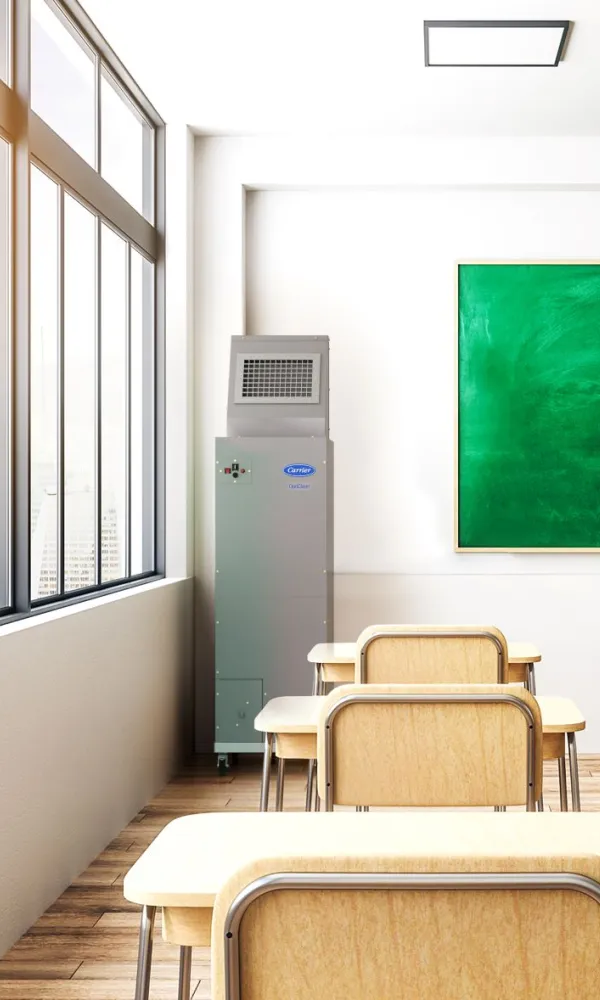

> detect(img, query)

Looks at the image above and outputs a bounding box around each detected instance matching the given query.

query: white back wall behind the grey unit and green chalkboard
[196,138,600,751]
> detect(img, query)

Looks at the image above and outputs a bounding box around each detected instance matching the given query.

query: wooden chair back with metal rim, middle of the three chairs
[317,684,542,811]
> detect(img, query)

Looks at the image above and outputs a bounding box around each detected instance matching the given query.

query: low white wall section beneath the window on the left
[0,580,192,955]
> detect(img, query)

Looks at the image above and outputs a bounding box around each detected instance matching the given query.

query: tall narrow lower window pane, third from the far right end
[64,194,96,591]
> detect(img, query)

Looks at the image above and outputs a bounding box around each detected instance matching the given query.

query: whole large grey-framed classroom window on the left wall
[0,0,164,624]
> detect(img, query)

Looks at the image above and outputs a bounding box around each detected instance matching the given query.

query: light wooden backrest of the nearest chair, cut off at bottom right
[212,844,600,1000]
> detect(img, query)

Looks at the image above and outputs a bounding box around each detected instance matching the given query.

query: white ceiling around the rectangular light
[82,0,600,135]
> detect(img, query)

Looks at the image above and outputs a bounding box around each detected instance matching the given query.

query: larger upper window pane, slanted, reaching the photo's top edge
[31,0,96,166]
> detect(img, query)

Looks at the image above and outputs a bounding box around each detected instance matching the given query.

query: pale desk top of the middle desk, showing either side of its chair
[254,685,585,734]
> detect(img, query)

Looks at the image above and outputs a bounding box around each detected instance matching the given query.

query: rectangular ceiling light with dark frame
[424,21,570,66]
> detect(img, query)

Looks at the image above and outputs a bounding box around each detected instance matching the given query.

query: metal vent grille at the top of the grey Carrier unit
[235,354,321,403]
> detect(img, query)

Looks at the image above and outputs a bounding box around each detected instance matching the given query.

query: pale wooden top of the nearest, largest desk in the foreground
[123,811,600,907]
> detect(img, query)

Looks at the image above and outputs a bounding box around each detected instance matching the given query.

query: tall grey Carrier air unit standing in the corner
[215,337,333,768]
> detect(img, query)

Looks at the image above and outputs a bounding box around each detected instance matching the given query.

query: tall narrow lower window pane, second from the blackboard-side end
[101,223,127,583]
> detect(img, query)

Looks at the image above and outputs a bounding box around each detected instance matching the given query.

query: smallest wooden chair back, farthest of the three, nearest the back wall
[354,625,508,684]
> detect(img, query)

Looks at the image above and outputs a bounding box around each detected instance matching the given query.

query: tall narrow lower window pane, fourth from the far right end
[31,167,59,600]
